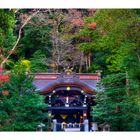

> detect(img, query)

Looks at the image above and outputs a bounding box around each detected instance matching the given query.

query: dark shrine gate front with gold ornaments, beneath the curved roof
[46,87,93,131]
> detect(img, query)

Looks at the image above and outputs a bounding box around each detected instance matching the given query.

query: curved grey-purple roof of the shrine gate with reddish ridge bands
[32,72,100,92]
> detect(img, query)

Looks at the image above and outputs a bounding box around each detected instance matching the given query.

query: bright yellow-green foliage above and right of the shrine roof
[78,9,139,74]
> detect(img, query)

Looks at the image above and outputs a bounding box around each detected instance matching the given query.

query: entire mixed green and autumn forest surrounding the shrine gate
[0,9,140,131]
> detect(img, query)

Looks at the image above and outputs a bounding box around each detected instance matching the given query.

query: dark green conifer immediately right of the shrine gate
[91,73,140,131]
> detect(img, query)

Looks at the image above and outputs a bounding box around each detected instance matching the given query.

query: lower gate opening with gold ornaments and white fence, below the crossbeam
[52,108,83,131]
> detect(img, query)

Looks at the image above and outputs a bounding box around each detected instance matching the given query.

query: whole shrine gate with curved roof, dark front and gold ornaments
[33,69,100,131]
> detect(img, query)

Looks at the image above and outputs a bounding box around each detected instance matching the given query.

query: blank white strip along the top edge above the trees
[0,0,140,8]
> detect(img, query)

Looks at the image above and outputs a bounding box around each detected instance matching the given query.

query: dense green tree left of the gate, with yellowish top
[0,62,47,131]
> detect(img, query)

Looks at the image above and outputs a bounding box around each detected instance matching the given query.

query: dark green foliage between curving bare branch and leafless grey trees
[13,17,51,72]
